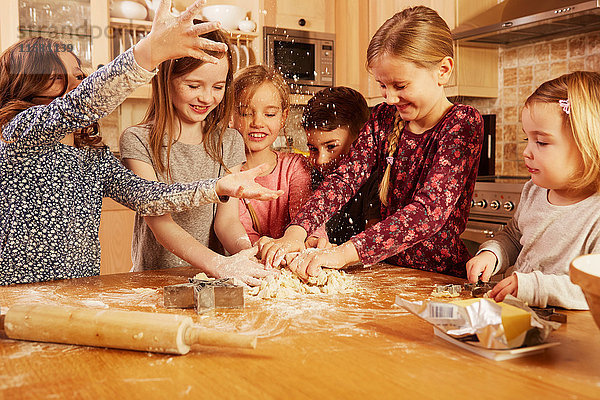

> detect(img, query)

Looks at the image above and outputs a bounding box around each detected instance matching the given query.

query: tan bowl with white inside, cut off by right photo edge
[570,254,600,328]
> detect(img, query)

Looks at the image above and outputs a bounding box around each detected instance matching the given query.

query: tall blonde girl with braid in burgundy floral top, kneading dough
[260,6,483,277]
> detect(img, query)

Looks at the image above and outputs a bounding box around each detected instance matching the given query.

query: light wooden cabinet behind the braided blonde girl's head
[335,0,498,105]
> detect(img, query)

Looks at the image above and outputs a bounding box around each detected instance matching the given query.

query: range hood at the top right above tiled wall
[452,0,600,46]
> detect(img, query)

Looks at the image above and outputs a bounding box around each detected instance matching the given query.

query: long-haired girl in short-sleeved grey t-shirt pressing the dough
[120,21,272,284]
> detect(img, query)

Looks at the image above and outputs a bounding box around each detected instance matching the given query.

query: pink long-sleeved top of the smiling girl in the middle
[239,152,327,244]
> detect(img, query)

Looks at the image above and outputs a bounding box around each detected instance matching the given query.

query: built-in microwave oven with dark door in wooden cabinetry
[263,26,335,94]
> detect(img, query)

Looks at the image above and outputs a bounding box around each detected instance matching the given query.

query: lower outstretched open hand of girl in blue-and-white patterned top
[215,164,283,200]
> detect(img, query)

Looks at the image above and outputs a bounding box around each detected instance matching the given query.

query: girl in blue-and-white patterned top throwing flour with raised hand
[0,2,278,285]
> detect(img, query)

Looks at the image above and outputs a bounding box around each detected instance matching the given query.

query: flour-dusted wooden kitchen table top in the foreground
[0,265,600,400]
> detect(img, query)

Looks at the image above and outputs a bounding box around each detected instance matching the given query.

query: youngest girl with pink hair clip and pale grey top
[467,71,600,309]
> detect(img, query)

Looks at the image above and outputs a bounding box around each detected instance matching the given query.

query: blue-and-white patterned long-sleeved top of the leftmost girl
[0,50,223,285]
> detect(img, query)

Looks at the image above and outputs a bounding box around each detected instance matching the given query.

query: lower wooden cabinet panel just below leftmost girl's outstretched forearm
[99,197,135,275]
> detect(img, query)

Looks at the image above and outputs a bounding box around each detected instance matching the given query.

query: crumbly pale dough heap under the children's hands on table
[248,268,355,299]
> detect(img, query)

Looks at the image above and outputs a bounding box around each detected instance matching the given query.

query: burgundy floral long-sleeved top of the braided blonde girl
[292,104,483,277]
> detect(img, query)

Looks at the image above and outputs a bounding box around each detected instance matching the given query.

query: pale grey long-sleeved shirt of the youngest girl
[480,181,600,310]
